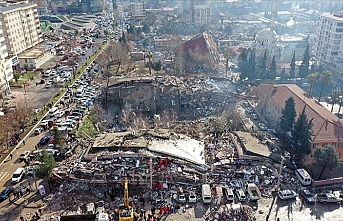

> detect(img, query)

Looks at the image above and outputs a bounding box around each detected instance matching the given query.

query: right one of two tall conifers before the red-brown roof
[292,106,313,157]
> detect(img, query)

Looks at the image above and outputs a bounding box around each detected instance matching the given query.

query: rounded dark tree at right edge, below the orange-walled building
[313,146,340,179]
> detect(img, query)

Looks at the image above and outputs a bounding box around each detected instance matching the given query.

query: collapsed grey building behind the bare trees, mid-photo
[108,76,232,117]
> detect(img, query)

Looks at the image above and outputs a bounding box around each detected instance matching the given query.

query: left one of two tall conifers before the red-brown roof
[280,97,297,137]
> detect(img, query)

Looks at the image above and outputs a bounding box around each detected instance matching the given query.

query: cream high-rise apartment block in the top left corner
[0,4,42,55]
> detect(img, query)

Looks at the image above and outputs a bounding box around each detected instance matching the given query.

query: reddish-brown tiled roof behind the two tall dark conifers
[259,84,343,143]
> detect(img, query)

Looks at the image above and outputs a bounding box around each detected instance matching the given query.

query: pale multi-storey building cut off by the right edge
[314,12,343,72]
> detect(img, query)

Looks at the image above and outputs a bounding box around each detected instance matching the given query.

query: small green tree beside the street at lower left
[35,150,56,179]
